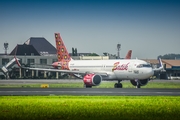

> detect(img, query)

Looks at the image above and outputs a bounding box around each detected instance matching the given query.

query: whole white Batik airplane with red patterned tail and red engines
[15,33,163,88]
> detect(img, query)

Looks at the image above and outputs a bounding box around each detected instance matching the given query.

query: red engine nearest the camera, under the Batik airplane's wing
[83,74,102,86]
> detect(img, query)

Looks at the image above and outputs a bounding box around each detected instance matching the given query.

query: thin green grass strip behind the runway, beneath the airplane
[0,81,180,88]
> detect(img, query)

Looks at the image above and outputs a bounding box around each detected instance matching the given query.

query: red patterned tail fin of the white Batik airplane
[55,33,71,62]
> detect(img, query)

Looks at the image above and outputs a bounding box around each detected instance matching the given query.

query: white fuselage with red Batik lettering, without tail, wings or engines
[69,59,154,80]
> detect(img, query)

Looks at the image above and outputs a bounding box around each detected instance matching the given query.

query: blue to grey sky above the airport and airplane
[0,0,180,59]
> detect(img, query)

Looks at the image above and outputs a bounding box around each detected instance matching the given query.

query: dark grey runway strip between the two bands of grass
[0,88,180,96]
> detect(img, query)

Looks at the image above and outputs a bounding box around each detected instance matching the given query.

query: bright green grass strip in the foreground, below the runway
[0,96,180,120]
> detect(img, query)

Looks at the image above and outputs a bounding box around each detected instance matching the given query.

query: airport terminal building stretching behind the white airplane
[0,37,180,79]
